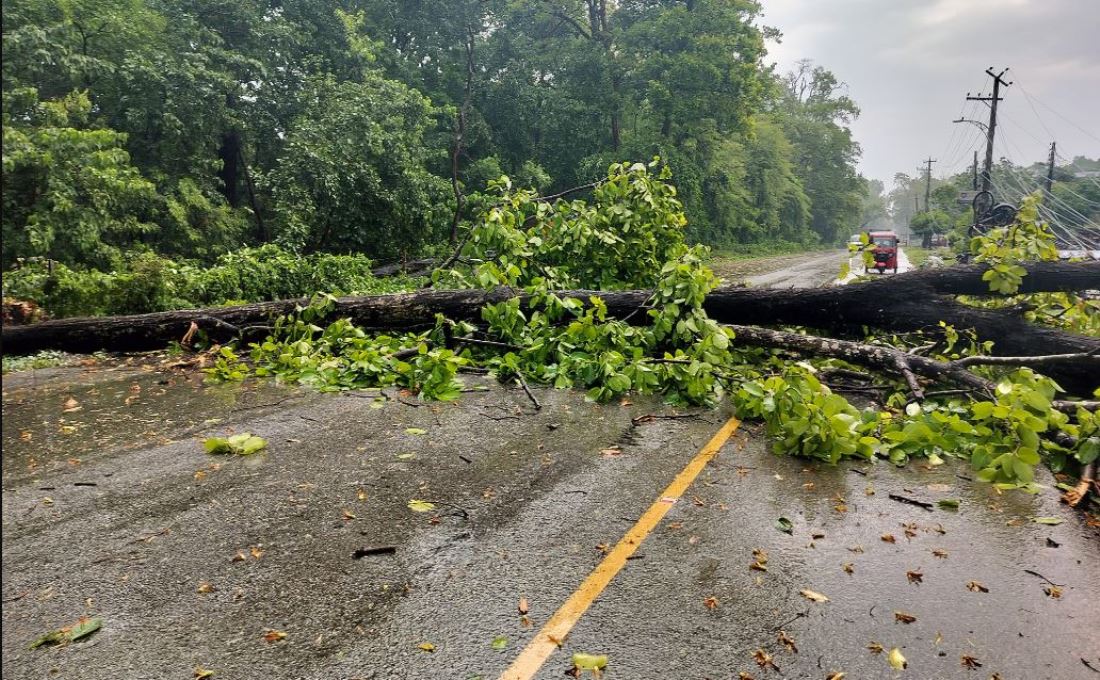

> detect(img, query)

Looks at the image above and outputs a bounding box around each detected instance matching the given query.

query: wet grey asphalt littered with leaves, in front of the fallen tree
[2,369,1100,680]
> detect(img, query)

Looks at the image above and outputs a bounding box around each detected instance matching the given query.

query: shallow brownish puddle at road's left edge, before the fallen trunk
[3,368,306,485]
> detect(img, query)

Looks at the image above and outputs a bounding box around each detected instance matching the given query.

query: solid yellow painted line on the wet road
[499,418,741,680]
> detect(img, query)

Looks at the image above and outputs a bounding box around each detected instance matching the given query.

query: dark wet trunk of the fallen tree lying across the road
[2,262,1100,390]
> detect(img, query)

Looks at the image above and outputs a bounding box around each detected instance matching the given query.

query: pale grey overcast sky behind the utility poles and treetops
[761,0,1100,188]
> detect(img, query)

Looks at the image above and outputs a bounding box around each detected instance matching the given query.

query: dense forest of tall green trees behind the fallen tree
[2,0,867,272]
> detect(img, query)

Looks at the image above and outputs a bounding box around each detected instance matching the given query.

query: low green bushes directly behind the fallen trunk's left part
[3,244,413,318]
